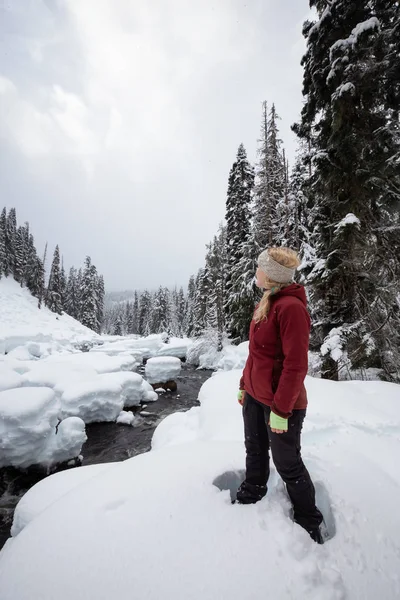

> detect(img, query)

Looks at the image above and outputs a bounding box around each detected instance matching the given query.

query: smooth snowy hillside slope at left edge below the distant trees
[0,277,99,353]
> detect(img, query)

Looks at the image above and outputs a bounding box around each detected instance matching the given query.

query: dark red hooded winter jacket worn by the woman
[240,283,310,418]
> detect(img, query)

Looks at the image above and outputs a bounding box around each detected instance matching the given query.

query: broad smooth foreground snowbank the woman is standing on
[0,370,400,600]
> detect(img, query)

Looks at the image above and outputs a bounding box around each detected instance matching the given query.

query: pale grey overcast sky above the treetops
[0,0,309,291]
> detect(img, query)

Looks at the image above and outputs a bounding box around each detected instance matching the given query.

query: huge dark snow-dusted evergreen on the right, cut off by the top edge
[295,0,400,380]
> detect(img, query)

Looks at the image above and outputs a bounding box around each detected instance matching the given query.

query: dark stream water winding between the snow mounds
[0,365,211,549]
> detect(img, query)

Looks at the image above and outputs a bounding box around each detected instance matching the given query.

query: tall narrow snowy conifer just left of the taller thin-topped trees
[224,144,254,341]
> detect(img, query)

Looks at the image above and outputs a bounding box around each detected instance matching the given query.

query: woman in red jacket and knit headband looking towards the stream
[237,248,323,543]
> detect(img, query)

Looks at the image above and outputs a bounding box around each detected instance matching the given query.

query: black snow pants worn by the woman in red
[243,394,322,531]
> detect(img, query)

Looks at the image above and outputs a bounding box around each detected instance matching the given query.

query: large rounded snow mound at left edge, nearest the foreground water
[0,387,86,468]
